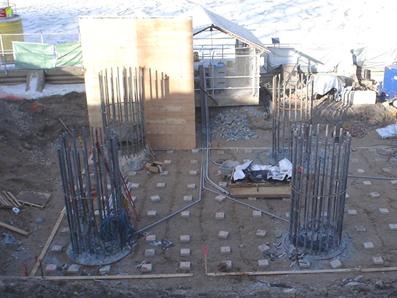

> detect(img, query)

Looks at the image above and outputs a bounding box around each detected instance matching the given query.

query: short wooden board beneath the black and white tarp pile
[228,182,291,199]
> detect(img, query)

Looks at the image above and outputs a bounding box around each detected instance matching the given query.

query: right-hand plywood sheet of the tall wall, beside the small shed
[137,18,196,149]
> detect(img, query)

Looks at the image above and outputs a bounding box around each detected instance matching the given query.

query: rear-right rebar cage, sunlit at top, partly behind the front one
[272,75,313,162]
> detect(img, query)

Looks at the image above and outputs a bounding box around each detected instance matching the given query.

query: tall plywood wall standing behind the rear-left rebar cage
[80,18,196,149]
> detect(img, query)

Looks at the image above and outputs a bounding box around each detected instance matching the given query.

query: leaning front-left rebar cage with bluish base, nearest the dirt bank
[57,131,134,265]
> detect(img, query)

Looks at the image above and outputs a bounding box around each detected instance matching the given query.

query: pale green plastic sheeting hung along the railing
[13,42,82,69]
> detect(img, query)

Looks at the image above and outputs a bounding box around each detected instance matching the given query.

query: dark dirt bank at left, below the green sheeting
[0,93,87,191]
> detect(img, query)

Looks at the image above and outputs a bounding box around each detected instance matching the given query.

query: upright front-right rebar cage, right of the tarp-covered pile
[289,123,351,255]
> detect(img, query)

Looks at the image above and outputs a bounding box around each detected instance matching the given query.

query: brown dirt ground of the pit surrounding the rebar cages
[0,93,397,297]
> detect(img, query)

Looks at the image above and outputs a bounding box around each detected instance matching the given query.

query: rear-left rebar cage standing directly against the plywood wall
[99,67,146,156]
